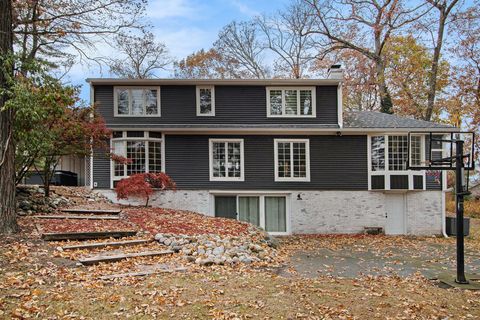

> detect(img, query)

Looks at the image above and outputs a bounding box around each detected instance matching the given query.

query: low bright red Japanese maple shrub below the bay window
[115,172,176,207]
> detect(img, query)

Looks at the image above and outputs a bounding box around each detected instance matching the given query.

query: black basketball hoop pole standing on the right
[455,140,468,284]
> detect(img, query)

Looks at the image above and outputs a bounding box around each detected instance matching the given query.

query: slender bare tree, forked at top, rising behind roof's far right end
[424,0,464,121]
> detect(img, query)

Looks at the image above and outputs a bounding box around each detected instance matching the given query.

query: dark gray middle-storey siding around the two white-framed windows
[165,135,368,190]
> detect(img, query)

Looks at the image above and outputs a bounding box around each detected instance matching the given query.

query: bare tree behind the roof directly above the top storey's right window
[257,3,315,79]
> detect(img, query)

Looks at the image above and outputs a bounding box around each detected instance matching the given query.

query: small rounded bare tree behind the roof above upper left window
[105,32,172,79]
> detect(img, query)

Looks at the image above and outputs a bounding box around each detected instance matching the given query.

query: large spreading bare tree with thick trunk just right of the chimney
[303,0,427,113]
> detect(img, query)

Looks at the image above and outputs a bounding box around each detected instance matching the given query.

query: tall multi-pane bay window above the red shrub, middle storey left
[112,131,165,187]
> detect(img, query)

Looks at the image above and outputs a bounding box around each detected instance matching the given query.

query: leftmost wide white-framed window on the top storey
[114,87,160,117]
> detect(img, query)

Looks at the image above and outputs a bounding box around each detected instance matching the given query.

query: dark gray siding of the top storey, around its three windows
[95,86,338,126]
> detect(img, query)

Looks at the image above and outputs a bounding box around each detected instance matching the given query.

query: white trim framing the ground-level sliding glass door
[209,190,290,236]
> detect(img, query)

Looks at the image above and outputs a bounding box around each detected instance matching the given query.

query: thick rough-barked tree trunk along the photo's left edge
[0,0,18,233]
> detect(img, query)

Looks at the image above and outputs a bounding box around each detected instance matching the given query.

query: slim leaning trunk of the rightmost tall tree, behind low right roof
[424,8,447,121]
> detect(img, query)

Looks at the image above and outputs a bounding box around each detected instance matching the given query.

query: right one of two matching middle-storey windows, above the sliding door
[274,139,310,181]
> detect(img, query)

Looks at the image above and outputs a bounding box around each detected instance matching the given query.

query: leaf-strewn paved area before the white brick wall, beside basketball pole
[280,243,480,279]
